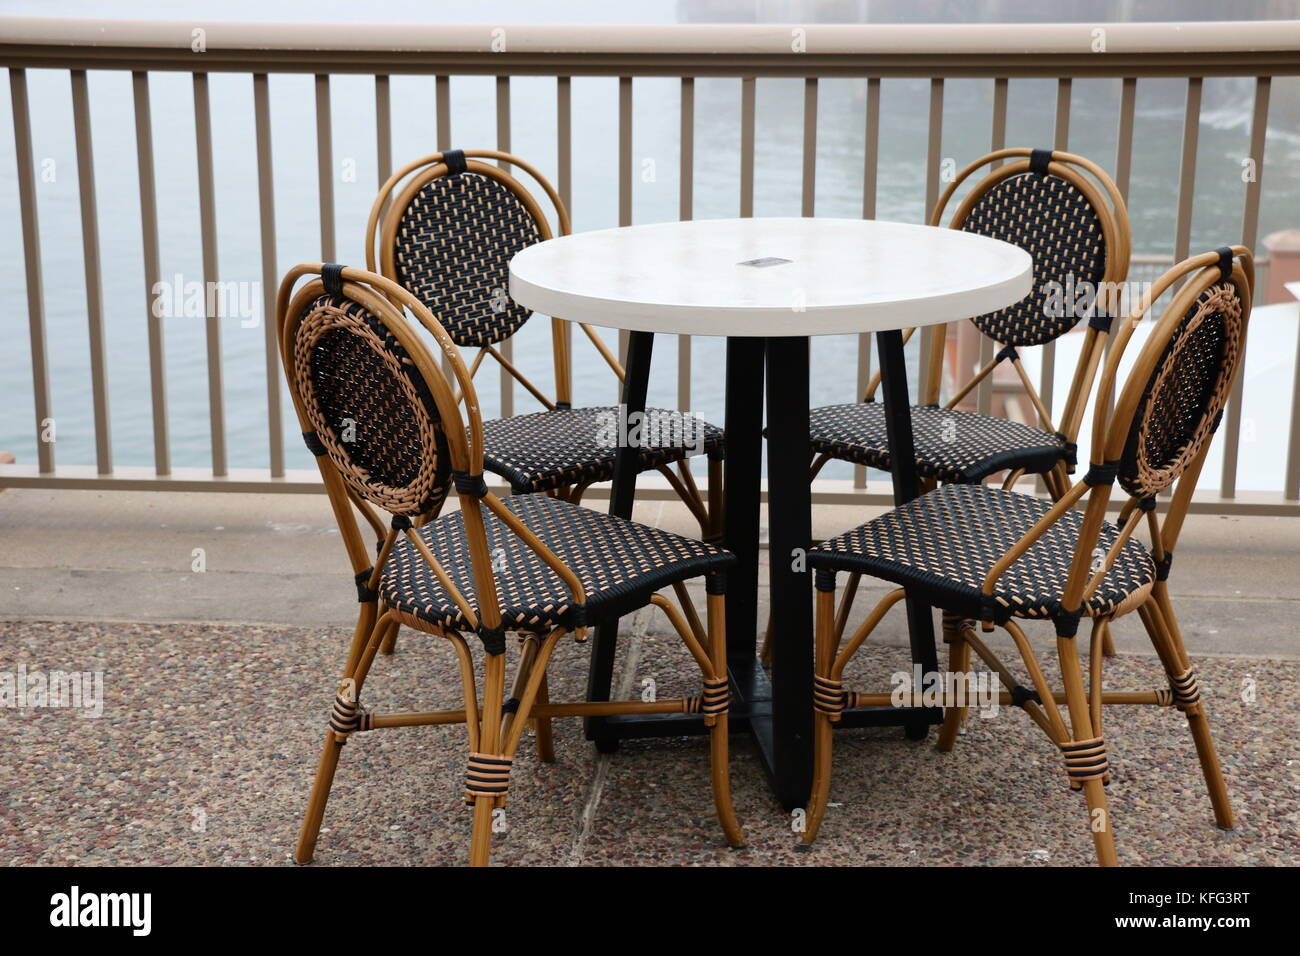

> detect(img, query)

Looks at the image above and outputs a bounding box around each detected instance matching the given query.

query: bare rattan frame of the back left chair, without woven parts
[365,150,723,541]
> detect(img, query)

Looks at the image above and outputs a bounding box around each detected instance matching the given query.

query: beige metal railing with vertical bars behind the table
[0,18,1300,514]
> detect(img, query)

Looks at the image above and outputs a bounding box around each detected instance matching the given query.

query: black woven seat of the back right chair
[809,402,1067,484]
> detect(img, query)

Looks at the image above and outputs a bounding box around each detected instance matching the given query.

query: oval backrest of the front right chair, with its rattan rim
[1106,248,1253,499]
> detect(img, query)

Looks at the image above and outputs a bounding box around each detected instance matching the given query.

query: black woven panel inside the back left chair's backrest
[394,173,541,349]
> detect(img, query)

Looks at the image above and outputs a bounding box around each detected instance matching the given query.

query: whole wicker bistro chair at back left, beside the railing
[365,150,723,541]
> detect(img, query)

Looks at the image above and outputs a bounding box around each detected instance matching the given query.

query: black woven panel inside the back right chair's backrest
[961,173,1106,346]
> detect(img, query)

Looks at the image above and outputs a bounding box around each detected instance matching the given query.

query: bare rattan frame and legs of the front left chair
[276,263,744,865]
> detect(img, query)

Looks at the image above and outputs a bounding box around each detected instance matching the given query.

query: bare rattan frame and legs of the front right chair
[801,246,1255,865]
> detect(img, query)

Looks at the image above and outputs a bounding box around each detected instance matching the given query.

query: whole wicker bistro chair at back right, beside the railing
[810,148,1130,498]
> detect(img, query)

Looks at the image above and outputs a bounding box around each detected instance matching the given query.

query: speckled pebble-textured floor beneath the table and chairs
[0,613,1300,865]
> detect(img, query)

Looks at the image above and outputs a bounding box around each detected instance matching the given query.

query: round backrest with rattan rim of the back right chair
[936,150,1128,346]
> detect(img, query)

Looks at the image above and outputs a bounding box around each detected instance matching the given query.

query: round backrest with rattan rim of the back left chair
[372,150,563,349]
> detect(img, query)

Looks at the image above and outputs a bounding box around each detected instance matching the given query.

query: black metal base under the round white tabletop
[585,332,943,810]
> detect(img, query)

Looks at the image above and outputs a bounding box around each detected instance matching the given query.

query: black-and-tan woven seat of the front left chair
[380,494,736,632]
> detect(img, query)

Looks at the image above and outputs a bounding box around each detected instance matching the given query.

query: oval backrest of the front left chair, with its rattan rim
[281,267,463,518]
